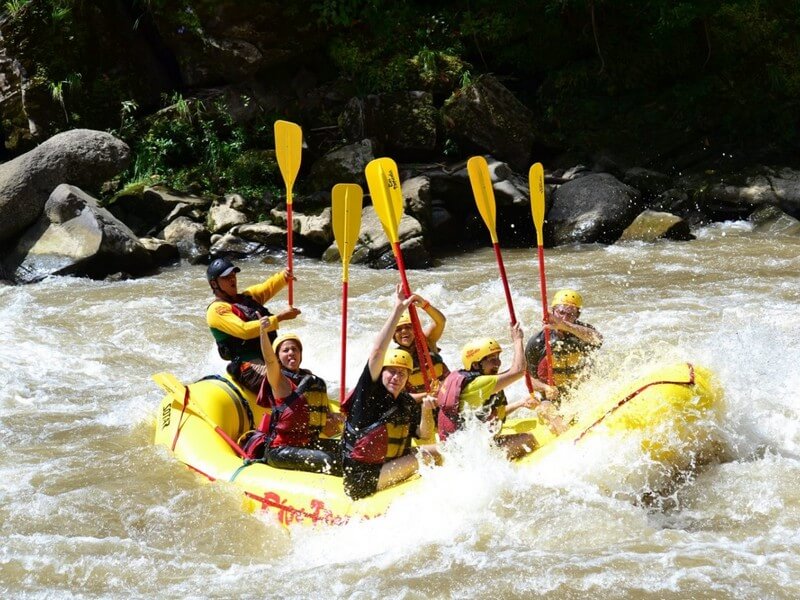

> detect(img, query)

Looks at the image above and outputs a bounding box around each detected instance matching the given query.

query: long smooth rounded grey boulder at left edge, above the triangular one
[0,129,130,244]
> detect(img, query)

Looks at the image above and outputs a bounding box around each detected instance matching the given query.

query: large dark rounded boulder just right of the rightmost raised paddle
[545,173,641,246]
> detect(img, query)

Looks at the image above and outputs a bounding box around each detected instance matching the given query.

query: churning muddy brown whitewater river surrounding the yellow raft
[0,223,800,598]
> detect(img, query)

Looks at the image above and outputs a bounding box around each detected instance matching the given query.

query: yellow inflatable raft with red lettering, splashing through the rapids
[153,363,722,525]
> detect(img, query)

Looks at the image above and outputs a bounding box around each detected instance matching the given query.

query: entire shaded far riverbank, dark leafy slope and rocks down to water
[0,0,800,283]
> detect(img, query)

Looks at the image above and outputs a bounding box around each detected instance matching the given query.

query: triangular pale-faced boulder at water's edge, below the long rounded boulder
[6,184,153,283]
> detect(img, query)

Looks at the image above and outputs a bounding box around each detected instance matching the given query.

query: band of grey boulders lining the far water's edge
[0,130,800,283]
